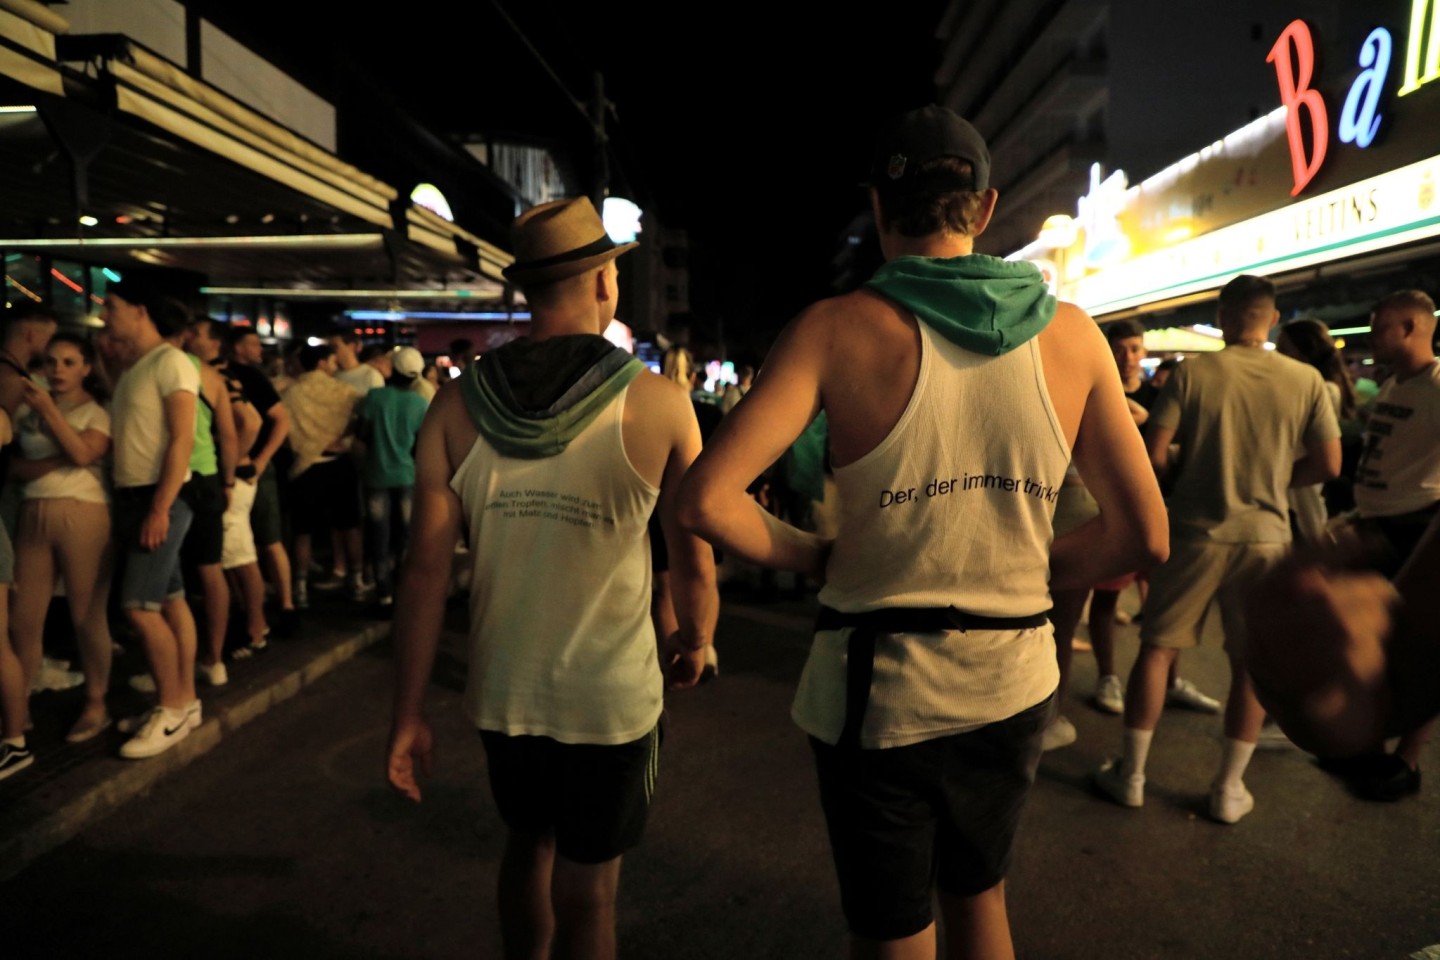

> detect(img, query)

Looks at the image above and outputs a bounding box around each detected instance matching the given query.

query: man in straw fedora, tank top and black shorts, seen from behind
[389,199,719,957]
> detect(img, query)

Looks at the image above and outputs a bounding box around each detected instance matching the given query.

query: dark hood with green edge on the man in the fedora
[461,334,645,459]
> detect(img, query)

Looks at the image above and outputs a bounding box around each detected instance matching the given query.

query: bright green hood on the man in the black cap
[865,253,1056,357]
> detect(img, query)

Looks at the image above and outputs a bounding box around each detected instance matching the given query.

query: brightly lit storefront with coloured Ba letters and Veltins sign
[1011,0,1440,352]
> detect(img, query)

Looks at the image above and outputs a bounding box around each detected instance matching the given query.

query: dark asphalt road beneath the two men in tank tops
[0,590,1440,960]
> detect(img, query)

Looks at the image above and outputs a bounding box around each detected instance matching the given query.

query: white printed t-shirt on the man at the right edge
[1355,361,1440,517]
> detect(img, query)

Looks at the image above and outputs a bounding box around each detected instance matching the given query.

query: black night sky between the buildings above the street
[200,0,945,345]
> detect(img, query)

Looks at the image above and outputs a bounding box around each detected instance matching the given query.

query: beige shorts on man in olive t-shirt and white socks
[1140,540,1290,658]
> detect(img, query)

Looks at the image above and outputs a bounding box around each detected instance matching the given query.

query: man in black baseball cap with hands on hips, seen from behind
[681,105,1166,957]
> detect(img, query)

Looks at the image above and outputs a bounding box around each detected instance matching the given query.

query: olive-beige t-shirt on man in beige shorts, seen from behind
[1146,347,1341,543]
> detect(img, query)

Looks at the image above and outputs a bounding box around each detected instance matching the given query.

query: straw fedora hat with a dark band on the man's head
[503,197,639,286]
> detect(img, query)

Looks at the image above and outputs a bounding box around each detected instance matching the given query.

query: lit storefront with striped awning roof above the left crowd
[0,0,513,341]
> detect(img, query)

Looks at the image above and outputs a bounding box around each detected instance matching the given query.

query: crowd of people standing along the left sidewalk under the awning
[0,287,438,779]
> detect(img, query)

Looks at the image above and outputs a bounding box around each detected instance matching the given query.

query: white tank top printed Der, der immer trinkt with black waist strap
[792,324,1070,747]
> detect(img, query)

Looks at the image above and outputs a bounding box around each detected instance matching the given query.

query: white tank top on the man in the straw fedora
[451,390,664,744]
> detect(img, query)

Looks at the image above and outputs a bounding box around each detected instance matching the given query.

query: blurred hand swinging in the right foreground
[1246,557,1398,757]
